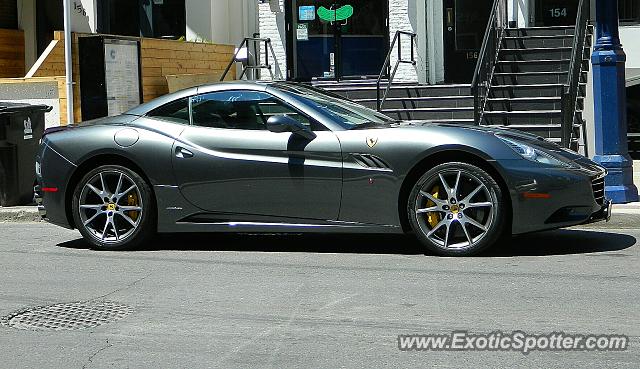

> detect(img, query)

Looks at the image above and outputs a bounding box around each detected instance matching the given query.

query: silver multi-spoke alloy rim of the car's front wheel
[414,169,497,250]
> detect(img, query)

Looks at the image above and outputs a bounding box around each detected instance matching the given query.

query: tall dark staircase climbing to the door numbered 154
[472,0,592,154]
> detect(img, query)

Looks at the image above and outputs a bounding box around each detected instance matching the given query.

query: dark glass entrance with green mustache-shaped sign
[288,0,389,81]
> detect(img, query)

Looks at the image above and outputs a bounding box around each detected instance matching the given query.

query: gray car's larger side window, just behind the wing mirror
[191,91,315,130]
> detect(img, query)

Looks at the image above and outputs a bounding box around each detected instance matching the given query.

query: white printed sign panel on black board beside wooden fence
[104,39,140,116]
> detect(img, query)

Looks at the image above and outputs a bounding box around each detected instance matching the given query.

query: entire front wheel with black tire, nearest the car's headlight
[407,163,505,256]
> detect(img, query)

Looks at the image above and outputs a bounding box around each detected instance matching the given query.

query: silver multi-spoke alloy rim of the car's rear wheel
[78,170,143,244]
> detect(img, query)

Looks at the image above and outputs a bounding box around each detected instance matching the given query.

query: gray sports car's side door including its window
[168,90,342,221]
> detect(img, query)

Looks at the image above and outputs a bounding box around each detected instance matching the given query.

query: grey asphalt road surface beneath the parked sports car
[0,215,640,368]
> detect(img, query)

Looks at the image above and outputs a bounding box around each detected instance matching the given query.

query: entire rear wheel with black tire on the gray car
[71,165,157,251]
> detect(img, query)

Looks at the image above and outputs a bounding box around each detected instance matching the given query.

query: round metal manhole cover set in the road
[0,301,133,331]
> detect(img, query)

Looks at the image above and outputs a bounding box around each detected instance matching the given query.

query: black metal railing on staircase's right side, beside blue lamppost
[561,0,591,154]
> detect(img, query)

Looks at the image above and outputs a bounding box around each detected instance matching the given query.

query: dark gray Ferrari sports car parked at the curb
[36,82,610,255]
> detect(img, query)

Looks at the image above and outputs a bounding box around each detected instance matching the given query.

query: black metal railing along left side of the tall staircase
[471,0,509,125]
